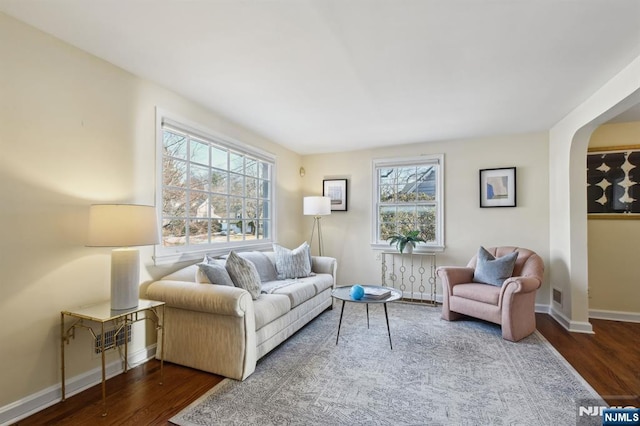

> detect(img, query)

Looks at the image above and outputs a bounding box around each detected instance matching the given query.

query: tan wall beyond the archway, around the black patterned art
[588,122,640,313]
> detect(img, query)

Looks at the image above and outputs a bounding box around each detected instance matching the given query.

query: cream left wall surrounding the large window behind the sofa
[0,14,302,410]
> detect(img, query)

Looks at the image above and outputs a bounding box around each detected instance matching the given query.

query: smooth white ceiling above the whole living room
[0,0,640,154]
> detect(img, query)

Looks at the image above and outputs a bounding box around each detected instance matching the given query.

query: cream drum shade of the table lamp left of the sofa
[87,204,160,247]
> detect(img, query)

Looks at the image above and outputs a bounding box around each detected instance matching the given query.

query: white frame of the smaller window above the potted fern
[371,154,445,252]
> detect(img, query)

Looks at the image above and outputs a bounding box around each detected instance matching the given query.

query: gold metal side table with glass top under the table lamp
[60,299,165,416]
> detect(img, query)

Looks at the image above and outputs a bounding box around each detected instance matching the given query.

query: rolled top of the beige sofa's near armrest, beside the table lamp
[146,280,252,317]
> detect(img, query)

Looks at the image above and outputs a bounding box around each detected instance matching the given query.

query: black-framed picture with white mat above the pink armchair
[480,167,516,207]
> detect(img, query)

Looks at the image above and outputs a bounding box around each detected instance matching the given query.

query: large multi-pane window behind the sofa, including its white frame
[156,111,275,260]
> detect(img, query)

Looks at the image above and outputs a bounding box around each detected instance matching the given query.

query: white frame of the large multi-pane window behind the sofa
[154,108,277,265]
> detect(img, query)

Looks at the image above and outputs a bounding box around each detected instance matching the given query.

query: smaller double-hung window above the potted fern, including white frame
[372,155,444,250]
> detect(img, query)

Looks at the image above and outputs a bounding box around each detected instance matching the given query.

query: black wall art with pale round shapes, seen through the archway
[587,145,640,219]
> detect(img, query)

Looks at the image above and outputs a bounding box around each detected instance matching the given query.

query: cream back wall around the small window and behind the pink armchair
[303,133,549,304]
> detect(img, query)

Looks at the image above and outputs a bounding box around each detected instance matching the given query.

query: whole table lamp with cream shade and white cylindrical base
[87,204,159,310]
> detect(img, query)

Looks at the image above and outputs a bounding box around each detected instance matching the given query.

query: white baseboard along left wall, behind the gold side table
[0,344,156,426]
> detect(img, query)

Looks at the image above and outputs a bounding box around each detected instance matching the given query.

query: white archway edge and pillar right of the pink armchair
[549,57,640,333]
